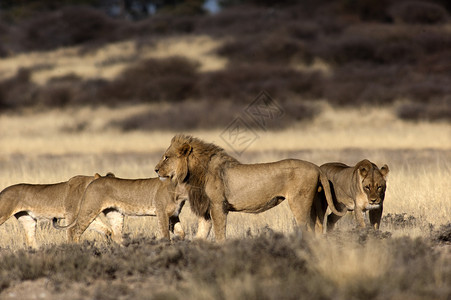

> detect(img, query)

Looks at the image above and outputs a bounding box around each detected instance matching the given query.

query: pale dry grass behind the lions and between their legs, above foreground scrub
[0,105,451,249]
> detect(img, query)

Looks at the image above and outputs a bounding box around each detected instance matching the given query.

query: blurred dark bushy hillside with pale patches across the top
[0,0,451,131]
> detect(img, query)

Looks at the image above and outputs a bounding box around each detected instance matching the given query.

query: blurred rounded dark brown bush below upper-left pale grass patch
[100,57,198,103]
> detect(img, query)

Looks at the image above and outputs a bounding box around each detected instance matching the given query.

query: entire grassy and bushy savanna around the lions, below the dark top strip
[0,1,451,299]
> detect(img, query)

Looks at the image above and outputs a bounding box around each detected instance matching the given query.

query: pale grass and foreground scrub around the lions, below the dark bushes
[0,103,451,299]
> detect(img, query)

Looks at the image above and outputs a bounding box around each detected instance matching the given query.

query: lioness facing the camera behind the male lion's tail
[317,159,389,232]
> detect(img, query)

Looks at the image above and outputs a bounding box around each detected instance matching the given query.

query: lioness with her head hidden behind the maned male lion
[53,177,186,244]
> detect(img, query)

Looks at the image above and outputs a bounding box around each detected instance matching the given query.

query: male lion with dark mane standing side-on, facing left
[155,135,344,241]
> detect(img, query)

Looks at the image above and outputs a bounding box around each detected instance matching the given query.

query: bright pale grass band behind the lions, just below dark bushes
[0,105,451,160]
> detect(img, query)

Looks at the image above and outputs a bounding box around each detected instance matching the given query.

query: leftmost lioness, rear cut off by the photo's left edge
[0,173,114,248]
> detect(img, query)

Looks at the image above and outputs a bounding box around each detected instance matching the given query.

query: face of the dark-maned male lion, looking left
[155,144,192,183]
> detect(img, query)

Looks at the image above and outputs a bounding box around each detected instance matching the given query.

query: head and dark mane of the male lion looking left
[155,134,237,216]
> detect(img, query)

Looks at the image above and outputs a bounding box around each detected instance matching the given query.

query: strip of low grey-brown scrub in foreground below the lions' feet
[0,229,451,299]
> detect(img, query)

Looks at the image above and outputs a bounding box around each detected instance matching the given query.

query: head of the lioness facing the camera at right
[355,159,389,209]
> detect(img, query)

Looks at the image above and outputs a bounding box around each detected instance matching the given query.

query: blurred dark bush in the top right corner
[389,1,449,24]
